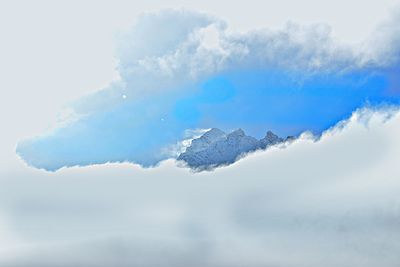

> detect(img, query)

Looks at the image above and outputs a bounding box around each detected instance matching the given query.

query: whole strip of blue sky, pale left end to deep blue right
[18,66,400,170]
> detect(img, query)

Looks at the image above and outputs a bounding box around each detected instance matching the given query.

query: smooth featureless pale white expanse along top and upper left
[0,0,398,138]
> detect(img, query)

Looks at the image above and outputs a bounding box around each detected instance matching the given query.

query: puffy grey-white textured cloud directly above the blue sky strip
[69,10,398,116]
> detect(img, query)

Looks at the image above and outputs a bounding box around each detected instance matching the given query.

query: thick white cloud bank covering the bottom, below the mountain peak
[0,108,400,267]
